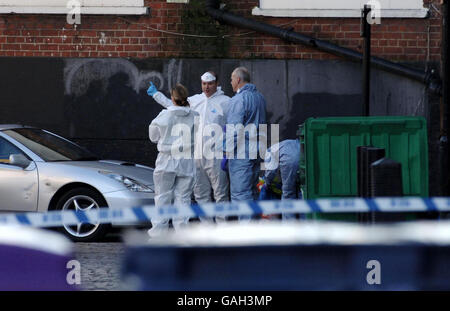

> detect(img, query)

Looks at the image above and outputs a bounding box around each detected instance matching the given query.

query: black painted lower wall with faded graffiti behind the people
[0,58,439,193]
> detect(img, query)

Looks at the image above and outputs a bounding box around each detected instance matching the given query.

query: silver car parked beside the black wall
[0,125,154,242]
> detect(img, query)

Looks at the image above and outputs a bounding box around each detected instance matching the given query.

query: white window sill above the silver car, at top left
[0,0,147,15]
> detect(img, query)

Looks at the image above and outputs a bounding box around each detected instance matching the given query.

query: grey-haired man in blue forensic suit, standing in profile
[224,67,266,207]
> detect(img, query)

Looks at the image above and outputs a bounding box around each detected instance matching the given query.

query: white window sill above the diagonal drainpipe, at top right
[252,0,428,18]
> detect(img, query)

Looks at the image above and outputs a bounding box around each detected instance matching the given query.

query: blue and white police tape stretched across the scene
[0,197,450,227]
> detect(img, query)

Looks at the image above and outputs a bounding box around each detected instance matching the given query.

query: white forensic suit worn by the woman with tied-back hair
[148,106,198,237]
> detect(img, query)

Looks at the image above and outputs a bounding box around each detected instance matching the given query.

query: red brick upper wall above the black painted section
[0,0,441,61]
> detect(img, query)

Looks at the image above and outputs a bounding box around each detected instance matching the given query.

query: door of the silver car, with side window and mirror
[0,136,39,212]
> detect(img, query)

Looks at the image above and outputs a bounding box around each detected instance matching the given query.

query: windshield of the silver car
[3,128,99,162]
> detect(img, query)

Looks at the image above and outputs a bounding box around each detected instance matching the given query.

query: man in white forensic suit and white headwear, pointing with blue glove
[147,71,230,212]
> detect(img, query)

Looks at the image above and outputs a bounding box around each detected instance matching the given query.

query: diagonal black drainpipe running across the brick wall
[206,0,442,95]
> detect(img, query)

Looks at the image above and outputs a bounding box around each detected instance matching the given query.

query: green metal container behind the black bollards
[299,116,428,220]
